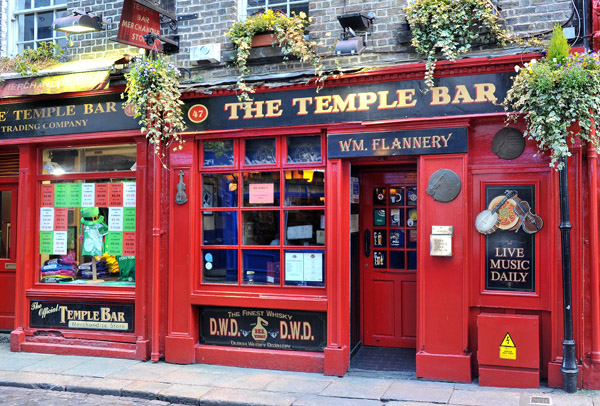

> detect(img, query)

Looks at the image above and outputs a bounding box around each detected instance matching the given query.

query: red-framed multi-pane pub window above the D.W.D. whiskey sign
[199,135,325,287]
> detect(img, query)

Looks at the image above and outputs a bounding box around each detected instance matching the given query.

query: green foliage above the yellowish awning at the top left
[0,42,65,76]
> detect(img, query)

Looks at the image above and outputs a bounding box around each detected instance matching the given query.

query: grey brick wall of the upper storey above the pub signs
[0,0,572,84]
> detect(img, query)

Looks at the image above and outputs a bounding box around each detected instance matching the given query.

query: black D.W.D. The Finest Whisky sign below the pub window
[200,307,327,351]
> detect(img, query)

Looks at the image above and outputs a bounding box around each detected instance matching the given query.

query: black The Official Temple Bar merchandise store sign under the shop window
[30,300,134,332]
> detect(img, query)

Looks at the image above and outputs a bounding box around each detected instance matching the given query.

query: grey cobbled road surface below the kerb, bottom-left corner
[0,386,188,406]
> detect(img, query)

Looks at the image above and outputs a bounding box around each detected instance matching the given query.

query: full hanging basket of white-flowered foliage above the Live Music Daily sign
[504,26,600,169]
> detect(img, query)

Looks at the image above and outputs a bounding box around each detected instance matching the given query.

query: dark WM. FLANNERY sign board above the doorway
[327,127,467,158]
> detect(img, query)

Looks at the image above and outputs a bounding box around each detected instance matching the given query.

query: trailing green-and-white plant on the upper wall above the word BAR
[406,0,510,87]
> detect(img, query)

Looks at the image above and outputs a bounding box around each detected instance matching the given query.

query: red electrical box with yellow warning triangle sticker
[477,314,540,388]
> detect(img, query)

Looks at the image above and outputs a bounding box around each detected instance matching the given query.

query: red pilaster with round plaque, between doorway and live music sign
[417,155,472,382]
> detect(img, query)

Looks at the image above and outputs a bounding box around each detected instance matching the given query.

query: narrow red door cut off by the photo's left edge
[0,183,17,330]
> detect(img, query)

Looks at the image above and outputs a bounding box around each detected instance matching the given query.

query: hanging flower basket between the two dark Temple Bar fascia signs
[121,55,185,166]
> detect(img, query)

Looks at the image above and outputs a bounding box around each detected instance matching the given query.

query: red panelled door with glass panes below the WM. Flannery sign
[360,171,418,348]
